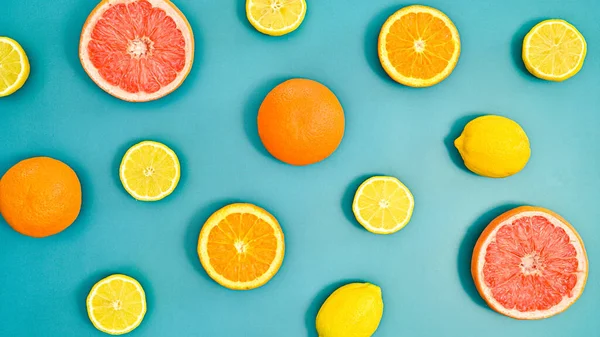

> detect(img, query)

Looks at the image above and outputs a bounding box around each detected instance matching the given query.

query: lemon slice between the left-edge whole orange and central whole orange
[119,141,181,201]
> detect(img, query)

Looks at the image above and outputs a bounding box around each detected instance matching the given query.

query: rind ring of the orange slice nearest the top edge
[378,5,461,88]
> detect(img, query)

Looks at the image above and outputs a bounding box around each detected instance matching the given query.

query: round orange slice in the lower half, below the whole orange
[198,204,285,290]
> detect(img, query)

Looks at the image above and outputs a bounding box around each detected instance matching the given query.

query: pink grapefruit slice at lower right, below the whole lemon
[471,206,588,319]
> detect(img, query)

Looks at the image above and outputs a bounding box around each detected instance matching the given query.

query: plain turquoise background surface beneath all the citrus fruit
[0,0,600,337]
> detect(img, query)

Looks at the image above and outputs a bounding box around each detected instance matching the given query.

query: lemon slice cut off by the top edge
[246,0,306,36]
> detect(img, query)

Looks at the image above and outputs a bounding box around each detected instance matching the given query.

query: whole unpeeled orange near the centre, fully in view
[258,79,345,165]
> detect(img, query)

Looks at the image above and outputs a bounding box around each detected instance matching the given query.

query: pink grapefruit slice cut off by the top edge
[79,0,194,102]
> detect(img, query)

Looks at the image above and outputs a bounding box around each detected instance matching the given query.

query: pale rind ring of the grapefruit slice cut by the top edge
[79,0,194,102]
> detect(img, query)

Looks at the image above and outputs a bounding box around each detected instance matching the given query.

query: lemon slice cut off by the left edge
[0,36,29,97]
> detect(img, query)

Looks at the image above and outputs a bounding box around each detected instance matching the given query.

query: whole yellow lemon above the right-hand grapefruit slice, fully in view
[454,115,531,178]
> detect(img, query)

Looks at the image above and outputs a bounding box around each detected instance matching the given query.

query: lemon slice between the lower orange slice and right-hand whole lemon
[352,176,415,234]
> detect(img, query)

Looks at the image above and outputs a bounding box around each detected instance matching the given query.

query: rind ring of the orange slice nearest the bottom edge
[198,203,285,290]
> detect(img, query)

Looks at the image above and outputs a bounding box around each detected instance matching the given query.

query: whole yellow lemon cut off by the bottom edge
[317,283,383,337]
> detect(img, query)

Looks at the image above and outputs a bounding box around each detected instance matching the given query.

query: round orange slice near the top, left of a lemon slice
[379,5,460,87]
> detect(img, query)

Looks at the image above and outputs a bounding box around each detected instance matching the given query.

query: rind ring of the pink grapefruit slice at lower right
[471,206,588,320]
